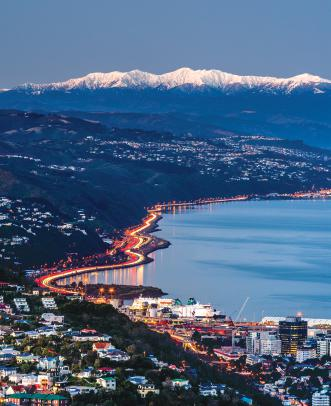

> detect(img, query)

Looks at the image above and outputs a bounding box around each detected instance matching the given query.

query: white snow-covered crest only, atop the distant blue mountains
[17,68,331,93]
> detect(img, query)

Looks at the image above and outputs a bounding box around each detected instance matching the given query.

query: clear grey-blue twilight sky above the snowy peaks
[0,0,331,87]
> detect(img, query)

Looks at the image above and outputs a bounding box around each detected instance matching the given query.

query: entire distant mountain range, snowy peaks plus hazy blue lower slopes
[0,68,331,148]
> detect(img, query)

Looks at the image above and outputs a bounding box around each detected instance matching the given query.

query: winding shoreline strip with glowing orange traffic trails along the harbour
[35,189,331,295]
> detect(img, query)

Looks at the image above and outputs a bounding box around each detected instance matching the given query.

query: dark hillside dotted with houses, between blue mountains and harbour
[0,110,331,232]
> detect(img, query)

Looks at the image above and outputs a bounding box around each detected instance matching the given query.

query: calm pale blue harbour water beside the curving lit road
[59,200,331,320]
